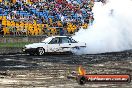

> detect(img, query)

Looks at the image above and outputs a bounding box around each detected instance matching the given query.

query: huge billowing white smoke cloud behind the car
[73,0,132,54]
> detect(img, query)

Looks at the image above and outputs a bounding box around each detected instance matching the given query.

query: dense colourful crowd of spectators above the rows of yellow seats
[0,0,94,34]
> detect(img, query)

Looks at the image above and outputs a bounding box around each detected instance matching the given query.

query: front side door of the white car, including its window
[47,37,60,52]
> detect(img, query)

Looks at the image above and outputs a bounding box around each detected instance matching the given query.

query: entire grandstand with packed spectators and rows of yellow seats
[0,0,94,36]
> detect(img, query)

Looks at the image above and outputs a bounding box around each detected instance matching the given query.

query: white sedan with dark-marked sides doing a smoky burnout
[23,36,86,55]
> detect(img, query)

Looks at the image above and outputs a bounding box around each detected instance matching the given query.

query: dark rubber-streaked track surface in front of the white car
[0,51,132,88]
